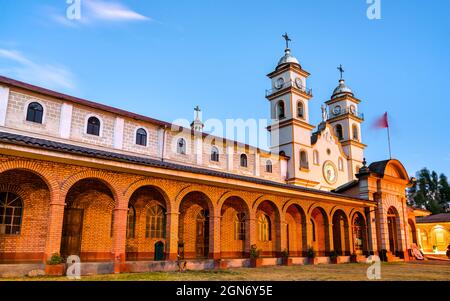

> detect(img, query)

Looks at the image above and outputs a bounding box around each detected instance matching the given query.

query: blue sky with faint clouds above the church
[0,0,450,176]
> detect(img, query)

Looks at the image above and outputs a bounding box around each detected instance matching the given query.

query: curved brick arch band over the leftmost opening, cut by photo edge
[0,161,58,203]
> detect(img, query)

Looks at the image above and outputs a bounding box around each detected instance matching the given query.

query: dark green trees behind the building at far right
[408,168,450,214]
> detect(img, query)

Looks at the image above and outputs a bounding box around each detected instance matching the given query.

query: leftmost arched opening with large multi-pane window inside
[0,169,51,263]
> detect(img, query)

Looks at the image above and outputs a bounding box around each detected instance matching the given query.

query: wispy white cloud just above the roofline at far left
[0,48,75,90]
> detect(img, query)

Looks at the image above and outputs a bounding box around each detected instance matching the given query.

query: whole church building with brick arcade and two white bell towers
[0,35,417,275]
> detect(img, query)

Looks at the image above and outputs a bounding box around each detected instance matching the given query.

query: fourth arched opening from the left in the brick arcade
[178,191,213,259]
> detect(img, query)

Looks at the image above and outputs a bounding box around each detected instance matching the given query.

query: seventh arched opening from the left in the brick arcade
[286,204,308,257]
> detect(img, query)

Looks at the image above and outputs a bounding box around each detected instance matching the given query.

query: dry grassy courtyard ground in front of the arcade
[1,261,450,281]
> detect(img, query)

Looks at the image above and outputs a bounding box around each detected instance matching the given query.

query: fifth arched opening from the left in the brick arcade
[220,196,250,258]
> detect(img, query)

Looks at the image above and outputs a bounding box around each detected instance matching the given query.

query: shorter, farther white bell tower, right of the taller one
[325,65,366,179]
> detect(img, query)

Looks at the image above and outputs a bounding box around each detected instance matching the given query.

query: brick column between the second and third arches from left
[113,208,128,273]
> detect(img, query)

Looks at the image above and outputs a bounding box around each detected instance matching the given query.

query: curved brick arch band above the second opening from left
[61,170,121,208]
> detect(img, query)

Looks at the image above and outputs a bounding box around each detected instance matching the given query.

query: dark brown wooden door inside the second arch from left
[61,209,84,257]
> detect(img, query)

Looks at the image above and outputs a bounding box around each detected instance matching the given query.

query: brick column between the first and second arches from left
[43,195,64,261]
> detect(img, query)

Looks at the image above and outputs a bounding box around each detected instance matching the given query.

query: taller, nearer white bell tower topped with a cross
[266,33,314,185]
